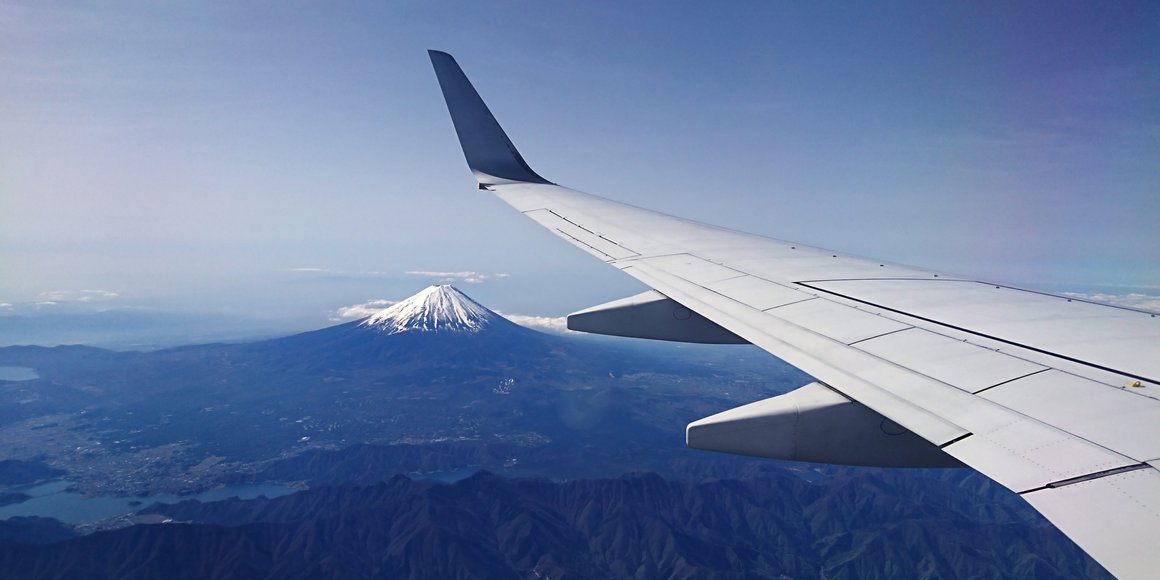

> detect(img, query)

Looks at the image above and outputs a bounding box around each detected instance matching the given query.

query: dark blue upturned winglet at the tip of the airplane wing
[427,50,551,189]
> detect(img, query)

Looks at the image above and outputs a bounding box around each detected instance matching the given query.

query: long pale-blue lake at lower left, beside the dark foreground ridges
[0,481,297,523]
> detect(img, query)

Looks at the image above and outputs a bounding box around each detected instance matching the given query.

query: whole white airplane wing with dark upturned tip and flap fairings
[430,51,1160,578]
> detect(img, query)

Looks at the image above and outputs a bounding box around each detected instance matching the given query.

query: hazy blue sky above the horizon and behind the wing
[0,0,1160,324]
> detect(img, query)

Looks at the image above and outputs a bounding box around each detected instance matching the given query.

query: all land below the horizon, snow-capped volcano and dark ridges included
[0,287,1103,578]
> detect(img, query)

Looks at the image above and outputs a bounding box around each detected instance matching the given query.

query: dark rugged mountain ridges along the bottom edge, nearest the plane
[0,472,1103,579]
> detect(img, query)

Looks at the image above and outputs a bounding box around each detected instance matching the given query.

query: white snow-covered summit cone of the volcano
[358,284,502,334]
